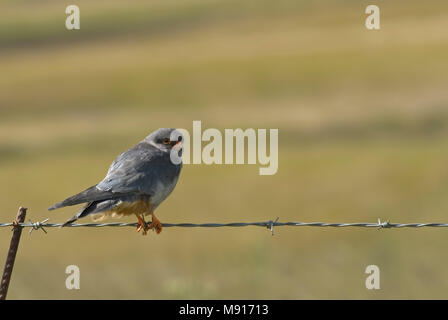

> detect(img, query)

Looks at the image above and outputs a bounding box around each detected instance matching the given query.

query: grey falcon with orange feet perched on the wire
[48,128,183,234]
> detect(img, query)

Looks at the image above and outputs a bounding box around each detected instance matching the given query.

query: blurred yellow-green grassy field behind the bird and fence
[0,0,448,299]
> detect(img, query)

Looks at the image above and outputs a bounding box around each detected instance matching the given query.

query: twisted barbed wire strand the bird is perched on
[0,218,448,235]
